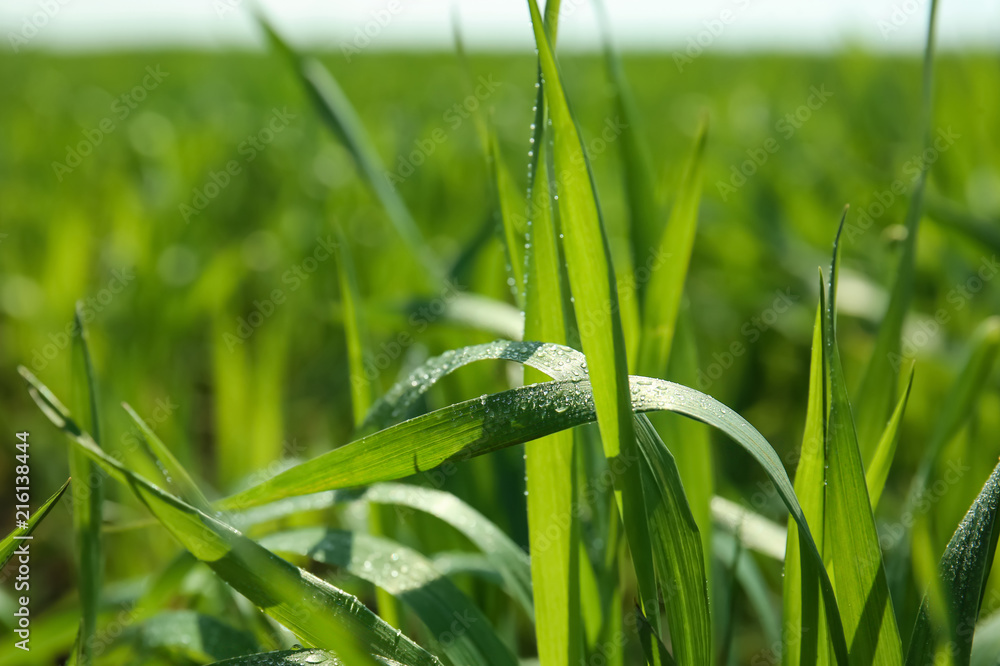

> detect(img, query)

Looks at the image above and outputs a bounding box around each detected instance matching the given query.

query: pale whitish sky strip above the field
[0,0,1000,54]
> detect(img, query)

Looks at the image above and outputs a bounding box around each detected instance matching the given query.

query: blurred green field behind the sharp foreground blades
[0,46,1000,650]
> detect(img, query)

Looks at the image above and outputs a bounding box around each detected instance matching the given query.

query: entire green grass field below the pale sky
[0,6,1000,665]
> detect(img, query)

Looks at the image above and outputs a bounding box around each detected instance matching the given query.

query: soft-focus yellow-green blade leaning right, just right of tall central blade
[636,121,708,377]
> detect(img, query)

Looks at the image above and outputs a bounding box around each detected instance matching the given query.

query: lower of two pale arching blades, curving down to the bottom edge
[259,527,518,666]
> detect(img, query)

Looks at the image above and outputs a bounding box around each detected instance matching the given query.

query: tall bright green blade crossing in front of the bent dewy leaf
[528,0,664,648]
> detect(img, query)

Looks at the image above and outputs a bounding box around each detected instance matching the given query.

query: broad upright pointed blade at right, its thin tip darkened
[820,226,903,664]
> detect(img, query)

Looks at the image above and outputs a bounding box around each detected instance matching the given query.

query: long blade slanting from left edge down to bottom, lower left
[20,367,440,666]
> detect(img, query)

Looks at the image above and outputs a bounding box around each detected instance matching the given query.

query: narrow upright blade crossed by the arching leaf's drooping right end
[781,305,830,666]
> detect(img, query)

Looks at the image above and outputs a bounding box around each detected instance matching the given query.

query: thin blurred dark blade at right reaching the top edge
[855,0,938,467]
